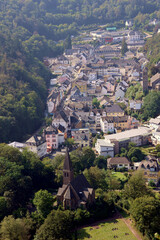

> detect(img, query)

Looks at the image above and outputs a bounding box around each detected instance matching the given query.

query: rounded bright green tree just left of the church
[33,190,53,218]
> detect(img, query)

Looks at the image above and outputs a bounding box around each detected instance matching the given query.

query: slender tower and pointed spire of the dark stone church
[63,148,73,185]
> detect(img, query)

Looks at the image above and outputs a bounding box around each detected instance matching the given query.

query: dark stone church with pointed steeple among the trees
[57,148,95,210]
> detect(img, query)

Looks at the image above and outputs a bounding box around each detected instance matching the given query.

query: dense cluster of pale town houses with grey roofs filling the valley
[8,27,160,186]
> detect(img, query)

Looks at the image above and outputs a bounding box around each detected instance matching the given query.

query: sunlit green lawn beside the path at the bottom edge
[78,219,137,240]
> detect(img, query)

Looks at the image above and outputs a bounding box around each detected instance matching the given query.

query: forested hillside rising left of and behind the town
[0,0,160,142]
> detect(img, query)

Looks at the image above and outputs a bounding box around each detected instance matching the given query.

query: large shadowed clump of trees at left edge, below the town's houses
[0,144,55,216]
